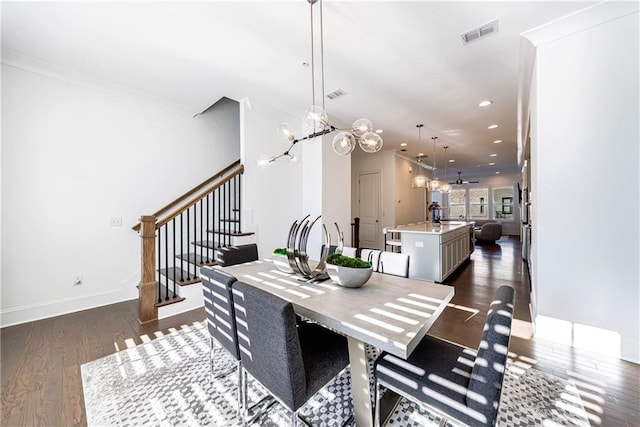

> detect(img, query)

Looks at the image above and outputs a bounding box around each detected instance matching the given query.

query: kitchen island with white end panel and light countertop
[388,221,475,283]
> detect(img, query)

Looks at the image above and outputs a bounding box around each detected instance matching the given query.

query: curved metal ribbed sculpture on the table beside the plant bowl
[287,215,344,280]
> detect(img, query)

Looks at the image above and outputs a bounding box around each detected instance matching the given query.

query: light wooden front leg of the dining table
[347,337,373,427]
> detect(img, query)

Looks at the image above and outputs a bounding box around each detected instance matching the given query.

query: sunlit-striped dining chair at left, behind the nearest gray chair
[200,267,243,413]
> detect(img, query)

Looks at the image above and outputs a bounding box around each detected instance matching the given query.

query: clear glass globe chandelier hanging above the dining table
[258,0,383,166]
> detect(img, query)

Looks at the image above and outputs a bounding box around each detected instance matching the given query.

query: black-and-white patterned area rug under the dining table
[81,324,589,427]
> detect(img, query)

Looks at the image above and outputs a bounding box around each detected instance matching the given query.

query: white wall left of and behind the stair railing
[1,63,240,326]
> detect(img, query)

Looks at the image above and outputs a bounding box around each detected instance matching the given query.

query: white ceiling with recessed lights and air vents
[2,0,595,178]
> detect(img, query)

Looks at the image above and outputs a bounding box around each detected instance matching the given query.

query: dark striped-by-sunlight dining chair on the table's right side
[374,286,515,426]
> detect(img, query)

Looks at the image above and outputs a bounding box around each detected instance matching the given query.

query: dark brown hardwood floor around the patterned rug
[0,238,640,426]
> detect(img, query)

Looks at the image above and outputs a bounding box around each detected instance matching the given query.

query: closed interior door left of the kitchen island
[358,171,381,249]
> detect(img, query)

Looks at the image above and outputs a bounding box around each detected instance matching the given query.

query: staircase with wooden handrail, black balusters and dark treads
[133,160,254,323]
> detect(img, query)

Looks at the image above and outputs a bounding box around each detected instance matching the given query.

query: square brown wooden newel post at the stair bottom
[138,215,158,323]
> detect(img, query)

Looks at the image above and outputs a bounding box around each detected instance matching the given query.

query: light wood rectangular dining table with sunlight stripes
[222,259,454,427]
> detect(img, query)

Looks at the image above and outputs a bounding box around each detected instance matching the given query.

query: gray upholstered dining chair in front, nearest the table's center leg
[233,281,351,425]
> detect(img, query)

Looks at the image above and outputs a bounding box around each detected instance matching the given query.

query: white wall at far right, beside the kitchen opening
[531,2,640,362]
